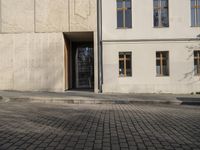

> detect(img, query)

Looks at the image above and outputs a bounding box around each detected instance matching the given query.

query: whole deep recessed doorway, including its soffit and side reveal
[64,32,94,92]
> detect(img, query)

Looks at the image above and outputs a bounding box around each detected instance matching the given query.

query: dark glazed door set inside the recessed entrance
[71,42,94,91]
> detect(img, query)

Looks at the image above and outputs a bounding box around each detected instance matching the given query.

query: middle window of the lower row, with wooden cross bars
[156,51,169,76]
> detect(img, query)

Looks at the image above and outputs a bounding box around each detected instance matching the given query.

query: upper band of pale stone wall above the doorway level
[0,0,96,33]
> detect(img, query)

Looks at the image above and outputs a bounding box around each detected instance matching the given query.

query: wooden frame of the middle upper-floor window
[153,0,170,28]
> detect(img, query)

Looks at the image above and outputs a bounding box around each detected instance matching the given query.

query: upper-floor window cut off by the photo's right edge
[191,0,200,27]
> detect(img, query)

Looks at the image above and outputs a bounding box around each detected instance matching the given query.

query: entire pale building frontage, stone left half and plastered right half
[0,0,200,93]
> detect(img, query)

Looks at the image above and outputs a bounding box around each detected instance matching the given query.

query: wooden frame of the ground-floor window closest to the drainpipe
[118,51,133,78]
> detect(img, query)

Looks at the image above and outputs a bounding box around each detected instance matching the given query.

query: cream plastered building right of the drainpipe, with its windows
[102,0,200,93]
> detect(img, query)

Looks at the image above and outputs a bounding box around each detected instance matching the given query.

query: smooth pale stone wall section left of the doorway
[0,33,64,91]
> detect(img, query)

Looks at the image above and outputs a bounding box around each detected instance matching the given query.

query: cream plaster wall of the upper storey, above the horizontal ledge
[102,0,200,40]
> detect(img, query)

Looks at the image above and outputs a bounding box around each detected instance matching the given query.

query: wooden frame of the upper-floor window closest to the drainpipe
[116,0,133,29]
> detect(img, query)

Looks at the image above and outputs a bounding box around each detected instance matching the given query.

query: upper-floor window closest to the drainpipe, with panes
[117,0,132,28]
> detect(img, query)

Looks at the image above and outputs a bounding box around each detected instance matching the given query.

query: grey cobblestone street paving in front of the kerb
[0,103,200,150]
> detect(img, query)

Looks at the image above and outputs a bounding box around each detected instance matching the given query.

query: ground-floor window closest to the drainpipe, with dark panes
[119,52,132,77]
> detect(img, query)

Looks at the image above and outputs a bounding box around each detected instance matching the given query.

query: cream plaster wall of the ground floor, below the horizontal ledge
[103,41,200,93]
